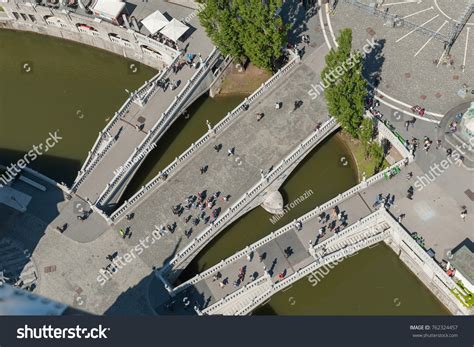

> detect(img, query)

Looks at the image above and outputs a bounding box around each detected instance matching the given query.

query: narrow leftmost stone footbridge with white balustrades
[71,48,229,209]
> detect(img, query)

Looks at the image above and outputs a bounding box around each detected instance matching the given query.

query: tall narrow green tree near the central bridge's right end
[321,29,367,137]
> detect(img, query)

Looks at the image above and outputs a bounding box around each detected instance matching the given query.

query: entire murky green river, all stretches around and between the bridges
[0,30,447,315]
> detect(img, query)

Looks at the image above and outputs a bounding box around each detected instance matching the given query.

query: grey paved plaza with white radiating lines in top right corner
[326,0,474,120]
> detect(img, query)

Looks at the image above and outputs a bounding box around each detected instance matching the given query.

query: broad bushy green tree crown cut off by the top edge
[199,0,288,70]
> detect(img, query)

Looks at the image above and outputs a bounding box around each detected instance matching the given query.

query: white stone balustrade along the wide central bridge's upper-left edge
[110,51,298,221]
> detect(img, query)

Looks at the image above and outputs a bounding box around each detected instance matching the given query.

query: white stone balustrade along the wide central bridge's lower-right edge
[162,118,339,271]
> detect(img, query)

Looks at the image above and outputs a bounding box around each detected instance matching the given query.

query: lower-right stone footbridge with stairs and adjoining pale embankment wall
[165,178,469,315]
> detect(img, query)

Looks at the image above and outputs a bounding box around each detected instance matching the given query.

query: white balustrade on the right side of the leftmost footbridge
[98,47,220,205]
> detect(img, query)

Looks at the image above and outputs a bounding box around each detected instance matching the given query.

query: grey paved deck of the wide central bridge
[112,47,327,274]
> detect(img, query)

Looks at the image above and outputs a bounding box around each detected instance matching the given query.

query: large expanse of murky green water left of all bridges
[0,30,156,184]
